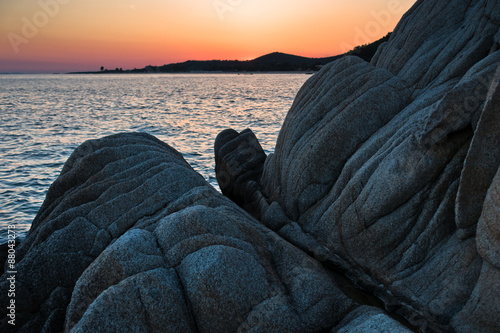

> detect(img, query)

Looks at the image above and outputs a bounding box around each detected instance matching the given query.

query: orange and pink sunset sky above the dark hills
[0,0,415,73]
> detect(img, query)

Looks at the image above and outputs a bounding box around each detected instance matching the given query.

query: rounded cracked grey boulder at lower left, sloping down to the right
[0,134,368,332]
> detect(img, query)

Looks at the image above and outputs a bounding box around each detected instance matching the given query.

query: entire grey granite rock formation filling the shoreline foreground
[0,0,500,332]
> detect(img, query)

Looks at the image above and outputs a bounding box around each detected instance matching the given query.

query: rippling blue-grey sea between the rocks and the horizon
[0,74,310,244]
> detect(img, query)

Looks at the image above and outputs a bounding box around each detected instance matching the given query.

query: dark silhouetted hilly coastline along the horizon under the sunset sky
[68,33,391,74]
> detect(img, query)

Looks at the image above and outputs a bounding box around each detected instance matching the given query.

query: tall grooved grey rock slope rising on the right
[216,0,500,332]
